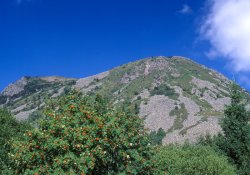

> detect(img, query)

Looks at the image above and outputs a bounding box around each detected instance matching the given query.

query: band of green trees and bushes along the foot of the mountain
[0,86,250,175]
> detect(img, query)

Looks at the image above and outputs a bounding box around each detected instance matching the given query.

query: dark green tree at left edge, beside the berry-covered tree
[0,109,30,174]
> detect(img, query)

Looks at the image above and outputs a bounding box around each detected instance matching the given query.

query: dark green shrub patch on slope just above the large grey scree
[150,84,178,99]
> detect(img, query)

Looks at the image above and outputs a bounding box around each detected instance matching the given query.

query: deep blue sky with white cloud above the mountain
[0,0,250,91]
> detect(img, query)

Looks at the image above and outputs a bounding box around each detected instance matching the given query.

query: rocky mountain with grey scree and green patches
[0,56,250,144]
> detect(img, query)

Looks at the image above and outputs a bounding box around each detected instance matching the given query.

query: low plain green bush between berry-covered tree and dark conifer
[152,145,235,175]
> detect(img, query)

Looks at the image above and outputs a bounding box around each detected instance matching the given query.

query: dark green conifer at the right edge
[219,84,250,174]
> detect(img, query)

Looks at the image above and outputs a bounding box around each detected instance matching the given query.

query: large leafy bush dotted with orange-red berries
[12,92,152,175]
